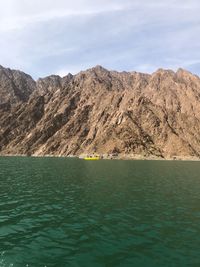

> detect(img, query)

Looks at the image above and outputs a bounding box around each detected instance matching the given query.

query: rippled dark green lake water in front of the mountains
[0,157,200,267]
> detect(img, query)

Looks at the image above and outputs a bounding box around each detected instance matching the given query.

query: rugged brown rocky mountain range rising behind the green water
[0,66,200,158]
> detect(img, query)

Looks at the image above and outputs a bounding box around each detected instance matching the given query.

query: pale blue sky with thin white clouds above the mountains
[0,0,200,79]
